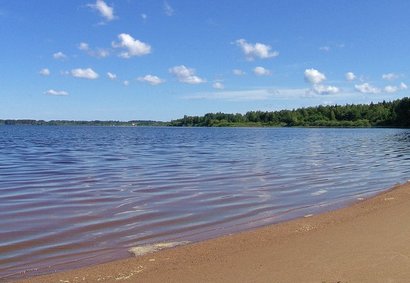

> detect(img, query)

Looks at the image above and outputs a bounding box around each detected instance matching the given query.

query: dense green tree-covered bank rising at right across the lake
[170,98,410,127]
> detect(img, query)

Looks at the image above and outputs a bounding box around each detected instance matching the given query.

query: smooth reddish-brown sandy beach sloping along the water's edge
[18,183,410,283]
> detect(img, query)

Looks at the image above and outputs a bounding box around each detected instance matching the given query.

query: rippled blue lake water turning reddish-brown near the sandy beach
[0,126,410,280]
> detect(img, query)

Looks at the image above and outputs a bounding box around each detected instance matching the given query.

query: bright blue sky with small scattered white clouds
[0,0,410,121]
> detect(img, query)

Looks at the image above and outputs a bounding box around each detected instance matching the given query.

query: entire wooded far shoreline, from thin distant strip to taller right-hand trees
[0,97,410,128]
